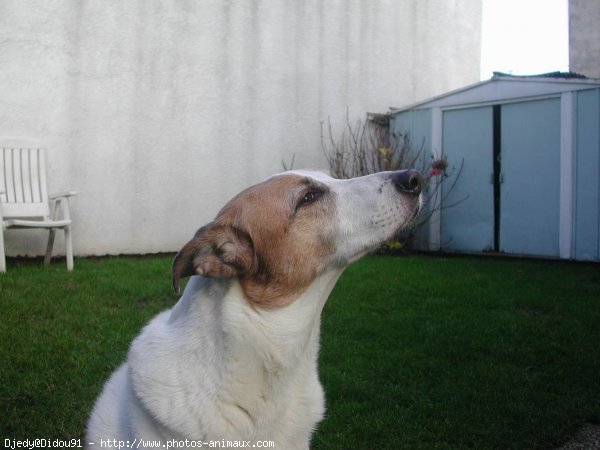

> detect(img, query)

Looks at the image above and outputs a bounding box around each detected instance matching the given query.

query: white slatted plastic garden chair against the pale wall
[0,138,76,272]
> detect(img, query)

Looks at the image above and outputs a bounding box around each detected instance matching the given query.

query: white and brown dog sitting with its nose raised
[86,170,421,449]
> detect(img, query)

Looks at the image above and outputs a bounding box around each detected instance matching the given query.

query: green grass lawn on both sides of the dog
[0,256,600,449]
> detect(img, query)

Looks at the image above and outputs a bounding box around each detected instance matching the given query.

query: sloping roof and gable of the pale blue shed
[389,72,600,115]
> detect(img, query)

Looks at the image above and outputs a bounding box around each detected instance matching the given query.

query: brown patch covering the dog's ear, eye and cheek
[173,174,335,308]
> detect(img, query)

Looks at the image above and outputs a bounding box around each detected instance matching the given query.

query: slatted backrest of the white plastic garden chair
[0,139,50,218]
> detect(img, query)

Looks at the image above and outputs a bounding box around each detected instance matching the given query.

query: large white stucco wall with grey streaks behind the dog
[0,0,481,255]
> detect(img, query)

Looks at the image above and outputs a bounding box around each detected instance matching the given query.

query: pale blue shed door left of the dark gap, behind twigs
[441,106,494,252]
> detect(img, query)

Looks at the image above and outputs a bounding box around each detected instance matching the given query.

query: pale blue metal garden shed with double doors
[390,73,600,261]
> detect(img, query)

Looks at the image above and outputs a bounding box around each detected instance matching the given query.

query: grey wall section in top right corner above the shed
[569,0,600,78]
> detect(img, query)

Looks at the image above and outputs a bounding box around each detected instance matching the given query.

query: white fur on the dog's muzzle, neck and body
[86,171,414,449]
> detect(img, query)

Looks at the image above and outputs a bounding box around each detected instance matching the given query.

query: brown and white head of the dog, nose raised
[173,170,420,307]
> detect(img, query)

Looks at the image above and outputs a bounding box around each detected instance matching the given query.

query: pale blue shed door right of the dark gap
[500,99,560,257]
